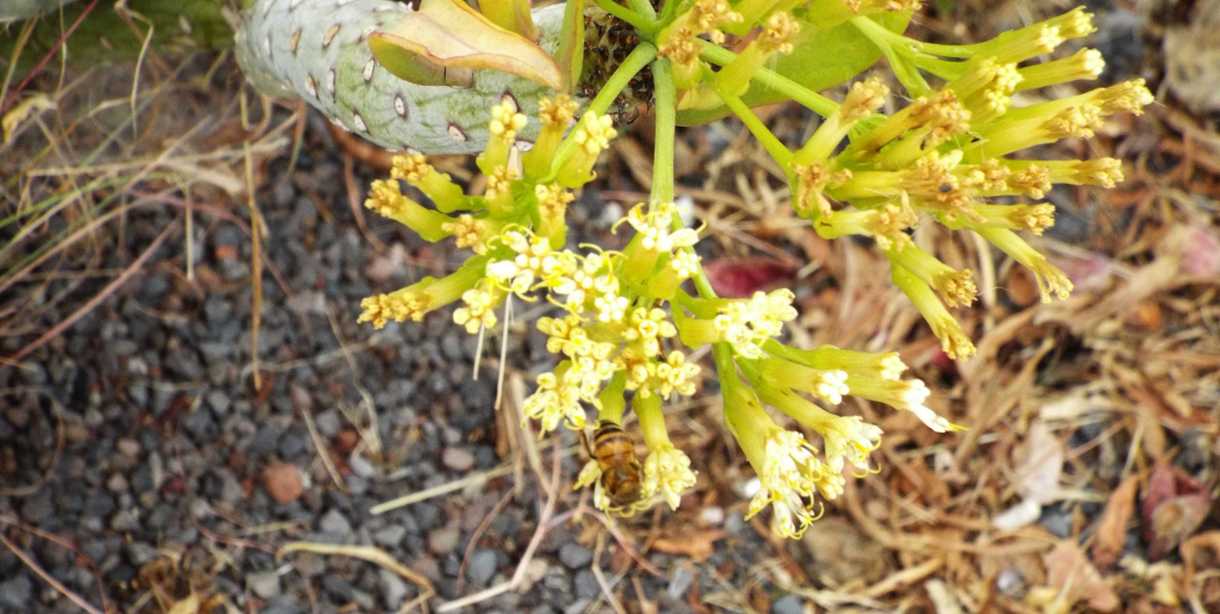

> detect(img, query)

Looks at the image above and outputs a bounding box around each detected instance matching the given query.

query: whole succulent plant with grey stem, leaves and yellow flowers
[250,0,1153,537]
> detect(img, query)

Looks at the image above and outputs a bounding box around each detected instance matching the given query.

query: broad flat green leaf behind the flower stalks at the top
[678,0,911,126]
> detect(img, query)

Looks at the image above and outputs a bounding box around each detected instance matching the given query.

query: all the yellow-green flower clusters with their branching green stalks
[344,0,1153,537]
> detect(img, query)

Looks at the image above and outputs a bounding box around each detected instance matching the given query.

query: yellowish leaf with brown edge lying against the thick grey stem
[368,0,564,89]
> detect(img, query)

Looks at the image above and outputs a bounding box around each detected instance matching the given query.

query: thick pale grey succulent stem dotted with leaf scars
[235,0,564,154]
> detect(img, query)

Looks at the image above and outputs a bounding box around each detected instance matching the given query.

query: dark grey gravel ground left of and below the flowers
[0,108,780,613]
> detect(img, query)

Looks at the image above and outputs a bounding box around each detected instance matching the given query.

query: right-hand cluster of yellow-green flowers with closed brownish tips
[781,2,1153,358]
